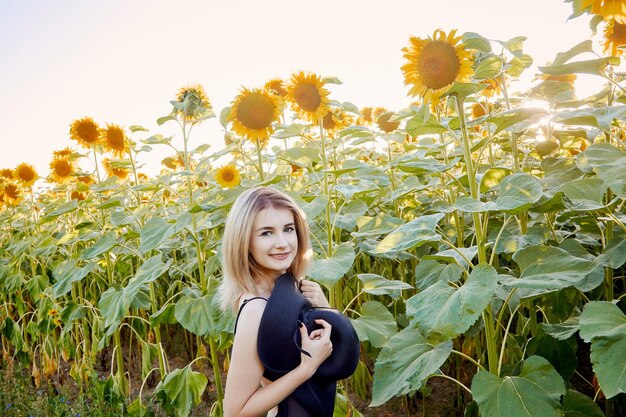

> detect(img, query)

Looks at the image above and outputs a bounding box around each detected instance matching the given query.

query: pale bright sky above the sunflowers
[0,0,600,176]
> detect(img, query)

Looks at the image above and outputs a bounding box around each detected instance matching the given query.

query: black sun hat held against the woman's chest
[257,273,360,417]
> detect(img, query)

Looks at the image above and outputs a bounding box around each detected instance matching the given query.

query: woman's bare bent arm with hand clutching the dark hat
[224,300,332,417]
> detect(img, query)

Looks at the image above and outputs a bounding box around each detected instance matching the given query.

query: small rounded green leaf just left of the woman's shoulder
[174,294,218,336]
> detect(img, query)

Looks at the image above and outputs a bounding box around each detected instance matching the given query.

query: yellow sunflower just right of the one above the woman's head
[286,71,329,124]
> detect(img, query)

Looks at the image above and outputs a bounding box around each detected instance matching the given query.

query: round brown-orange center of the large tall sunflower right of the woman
[417,41,461,90]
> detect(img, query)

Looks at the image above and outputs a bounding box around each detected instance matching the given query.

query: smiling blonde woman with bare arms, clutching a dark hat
[220,187,334,417]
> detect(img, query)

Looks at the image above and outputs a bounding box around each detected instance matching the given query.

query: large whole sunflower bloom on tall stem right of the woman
[402,29,472,102]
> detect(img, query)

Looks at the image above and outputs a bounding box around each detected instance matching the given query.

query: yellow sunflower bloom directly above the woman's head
[229,88,280,142]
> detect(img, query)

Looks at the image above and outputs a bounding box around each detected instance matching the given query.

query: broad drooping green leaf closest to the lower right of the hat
[370,328,452,407]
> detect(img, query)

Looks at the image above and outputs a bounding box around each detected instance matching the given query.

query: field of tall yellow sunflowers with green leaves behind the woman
[0,0,626,417]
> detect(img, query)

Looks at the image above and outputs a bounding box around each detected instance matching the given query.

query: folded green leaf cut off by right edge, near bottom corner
[580,301,626,398]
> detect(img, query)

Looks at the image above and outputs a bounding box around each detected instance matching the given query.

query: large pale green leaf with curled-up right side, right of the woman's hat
[406,264,497,340]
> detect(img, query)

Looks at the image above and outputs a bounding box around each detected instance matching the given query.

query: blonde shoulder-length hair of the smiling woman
[219,187,311,310]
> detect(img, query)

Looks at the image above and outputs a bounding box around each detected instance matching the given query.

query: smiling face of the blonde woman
[250,207,298,277]
